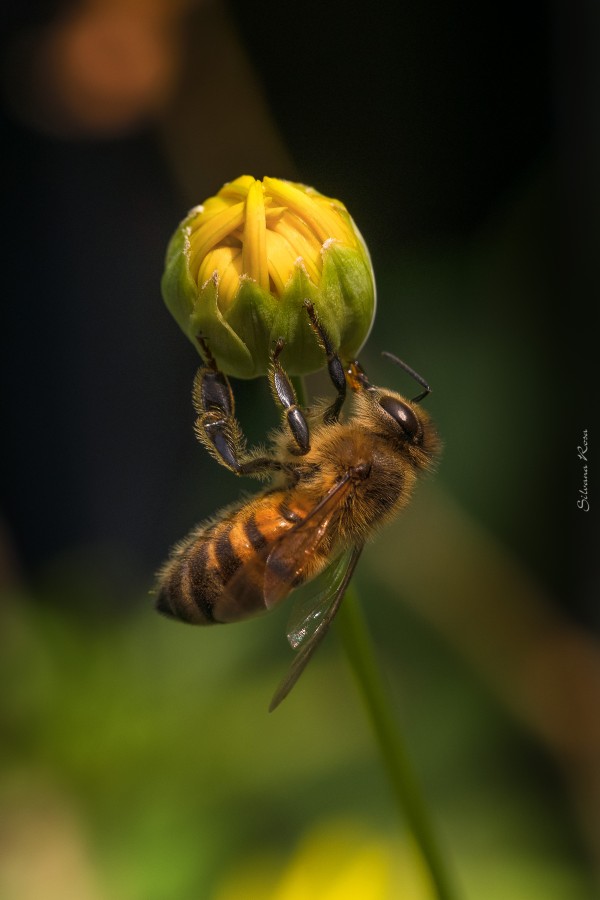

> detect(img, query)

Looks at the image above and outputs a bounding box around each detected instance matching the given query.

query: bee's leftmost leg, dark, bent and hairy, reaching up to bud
[192,336,282,475]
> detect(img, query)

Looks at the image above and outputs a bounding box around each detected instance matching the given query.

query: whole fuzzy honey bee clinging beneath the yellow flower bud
[156,300,440,710]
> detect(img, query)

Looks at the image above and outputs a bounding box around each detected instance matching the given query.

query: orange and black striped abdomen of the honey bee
[156,490,326,625]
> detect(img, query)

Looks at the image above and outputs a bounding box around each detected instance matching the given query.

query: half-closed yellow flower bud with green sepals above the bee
[162,175,375,378]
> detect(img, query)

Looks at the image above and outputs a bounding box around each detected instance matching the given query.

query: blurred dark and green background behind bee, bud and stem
[0,0,600,900]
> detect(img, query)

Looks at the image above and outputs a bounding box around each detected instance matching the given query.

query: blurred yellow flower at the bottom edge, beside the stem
[211,819,436,900]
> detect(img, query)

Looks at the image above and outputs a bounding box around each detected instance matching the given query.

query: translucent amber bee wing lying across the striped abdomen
[264,475,350,609]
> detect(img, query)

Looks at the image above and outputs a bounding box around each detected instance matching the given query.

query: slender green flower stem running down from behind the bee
[292,376,456,900]
